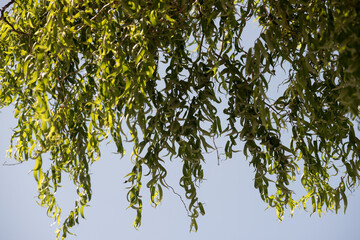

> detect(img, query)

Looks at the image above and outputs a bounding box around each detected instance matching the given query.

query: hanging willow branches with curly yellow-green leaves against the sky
[0,0,360,238]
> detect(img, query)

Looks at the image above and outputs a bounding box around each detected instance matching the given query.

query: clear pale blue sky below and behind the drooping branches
[0,0,360,240]
